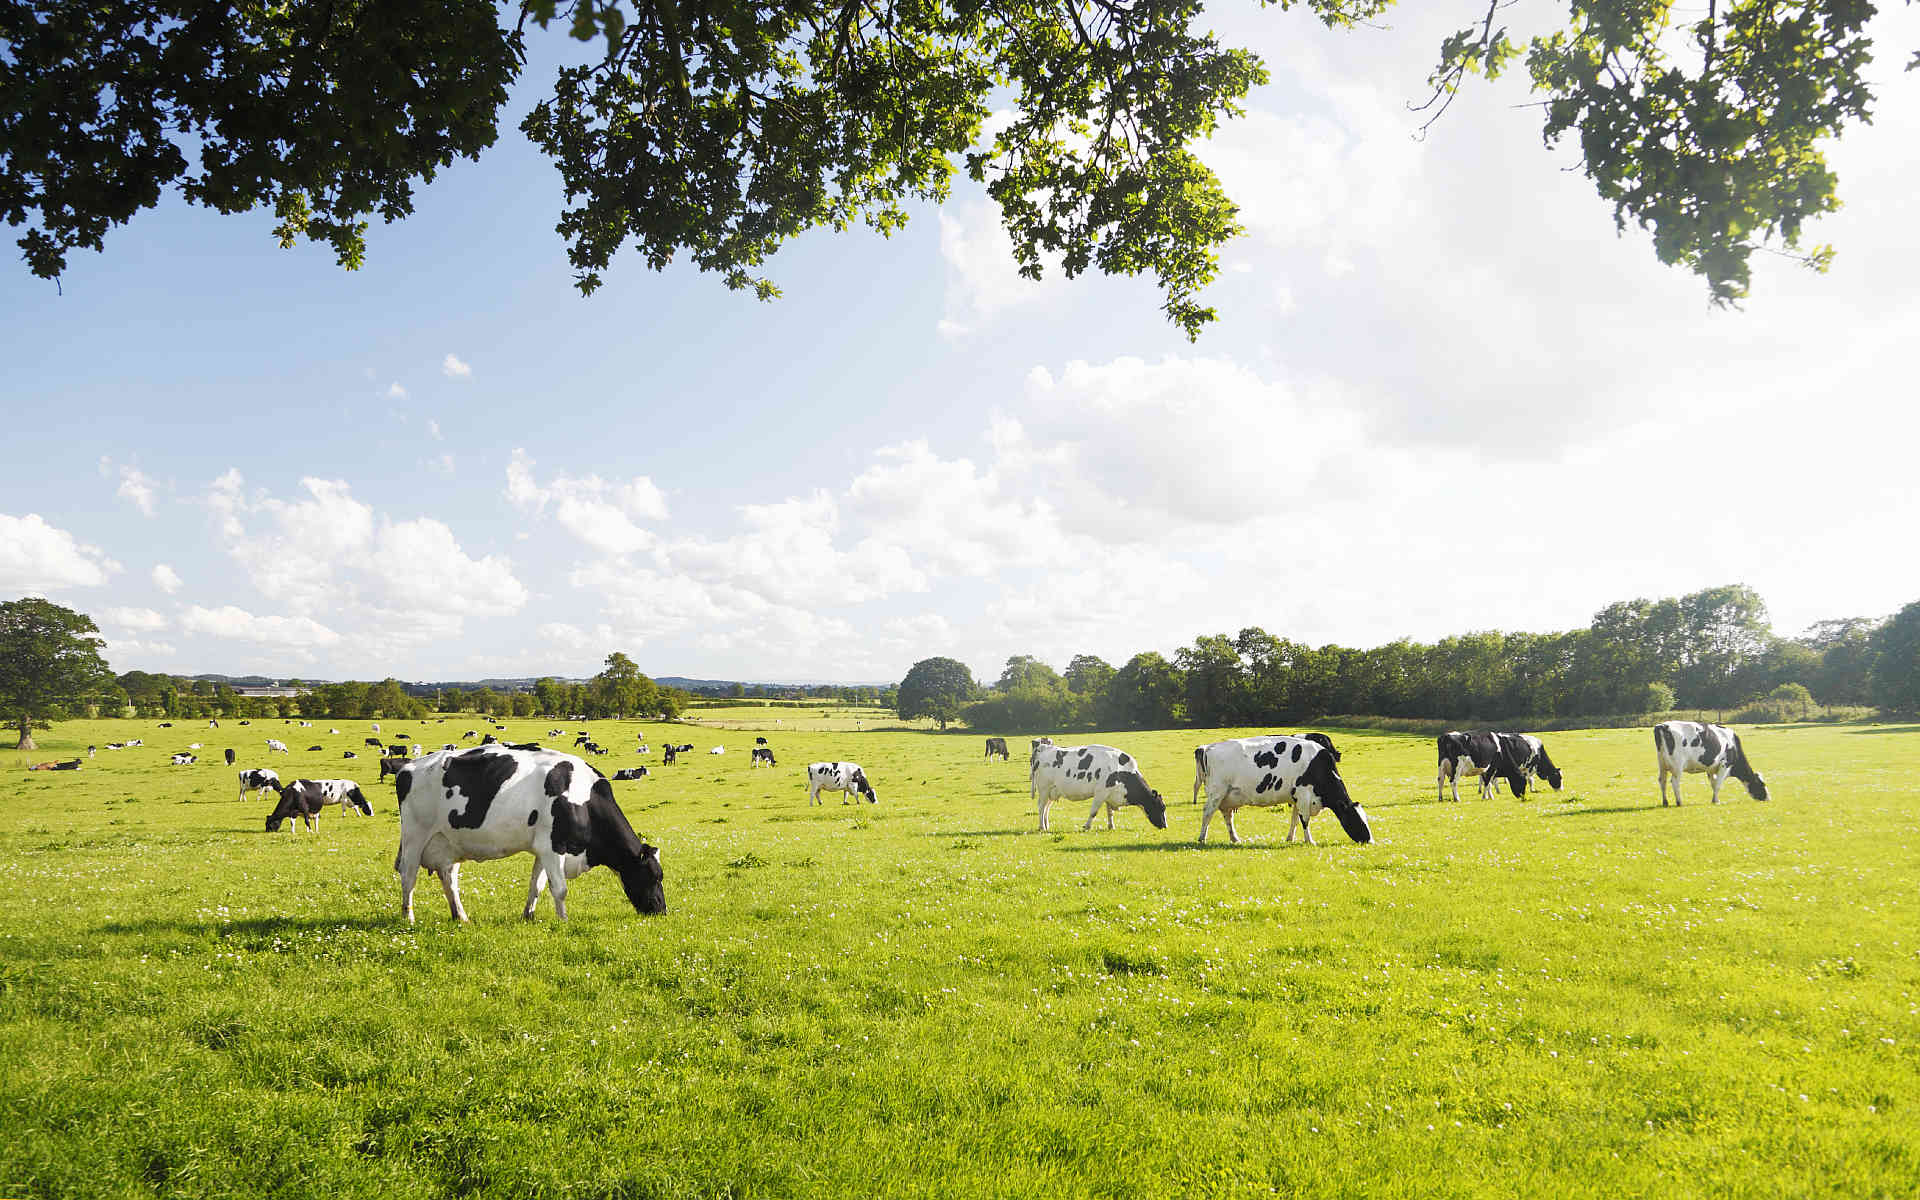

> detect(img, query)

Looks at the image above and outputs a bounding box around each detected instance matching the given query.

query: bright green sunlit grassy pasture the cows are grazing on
[0,718,1920,1200]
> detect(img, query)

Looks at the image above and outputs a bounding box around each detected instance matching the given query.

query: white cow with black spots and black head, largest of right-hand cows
[1194,733,1373,845]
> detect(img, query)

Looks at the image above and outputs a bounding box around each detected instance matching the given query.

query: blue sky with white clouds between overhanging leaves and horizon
[0,6,1920,680]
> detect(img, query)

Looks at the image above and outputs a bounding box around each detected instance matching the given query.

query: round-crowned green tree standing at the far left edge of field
[0,595,113,751]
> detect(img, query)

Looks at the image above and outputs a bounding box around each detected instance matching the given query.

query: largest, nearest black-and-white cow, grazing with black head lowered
[394,745,666,924]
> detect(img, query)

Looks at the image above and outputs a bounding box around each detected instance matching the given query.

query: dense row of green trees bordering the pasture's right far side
[899,584,1920,732]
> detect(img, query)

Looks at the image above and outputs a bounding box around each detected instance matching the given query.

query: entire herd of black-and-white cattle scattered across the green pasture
[61,720,1768,922]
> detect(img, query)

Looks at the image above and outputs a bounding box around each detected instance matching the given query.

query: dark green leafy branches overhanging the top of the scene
[0,0,1874,336]
